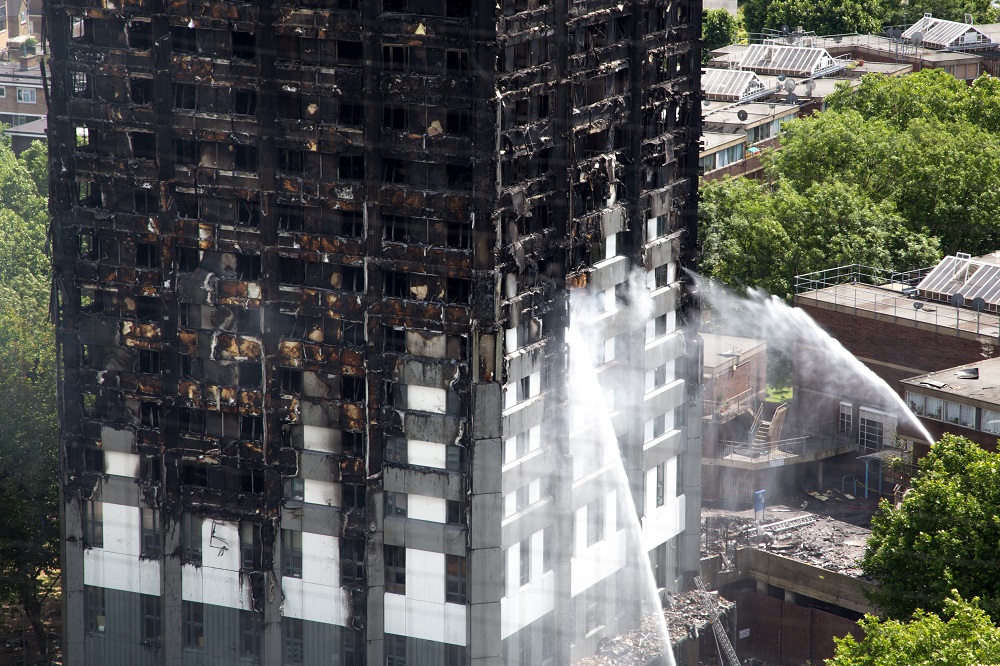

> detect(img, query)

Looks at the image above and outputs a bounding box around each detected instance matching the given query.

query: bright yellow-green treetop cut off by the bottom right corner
[826,594,1000,666]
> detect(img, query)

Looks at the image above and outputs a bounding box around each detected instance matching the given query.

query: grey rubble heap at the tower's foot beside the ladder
[575,590,735,666]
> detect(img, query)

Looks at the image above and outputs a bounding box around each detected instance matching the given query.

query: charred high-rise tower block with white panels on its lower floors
[46,0,701,666]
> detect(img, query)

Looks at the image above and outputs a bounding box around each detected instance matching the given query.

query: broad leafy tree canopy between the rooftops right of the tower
[699,70,1000,296]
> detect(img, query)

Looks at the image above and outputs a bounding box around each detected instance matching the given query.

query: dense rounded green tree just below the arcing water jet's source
[861,435,1000,620]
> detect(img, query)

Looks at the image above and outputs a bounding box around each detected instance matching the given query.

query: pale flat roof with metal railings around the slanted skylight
[795,283,1000,339]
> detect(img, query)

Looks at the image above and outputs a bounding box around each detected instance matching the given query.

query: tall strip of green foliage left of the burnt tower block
[0,134,59,654]
